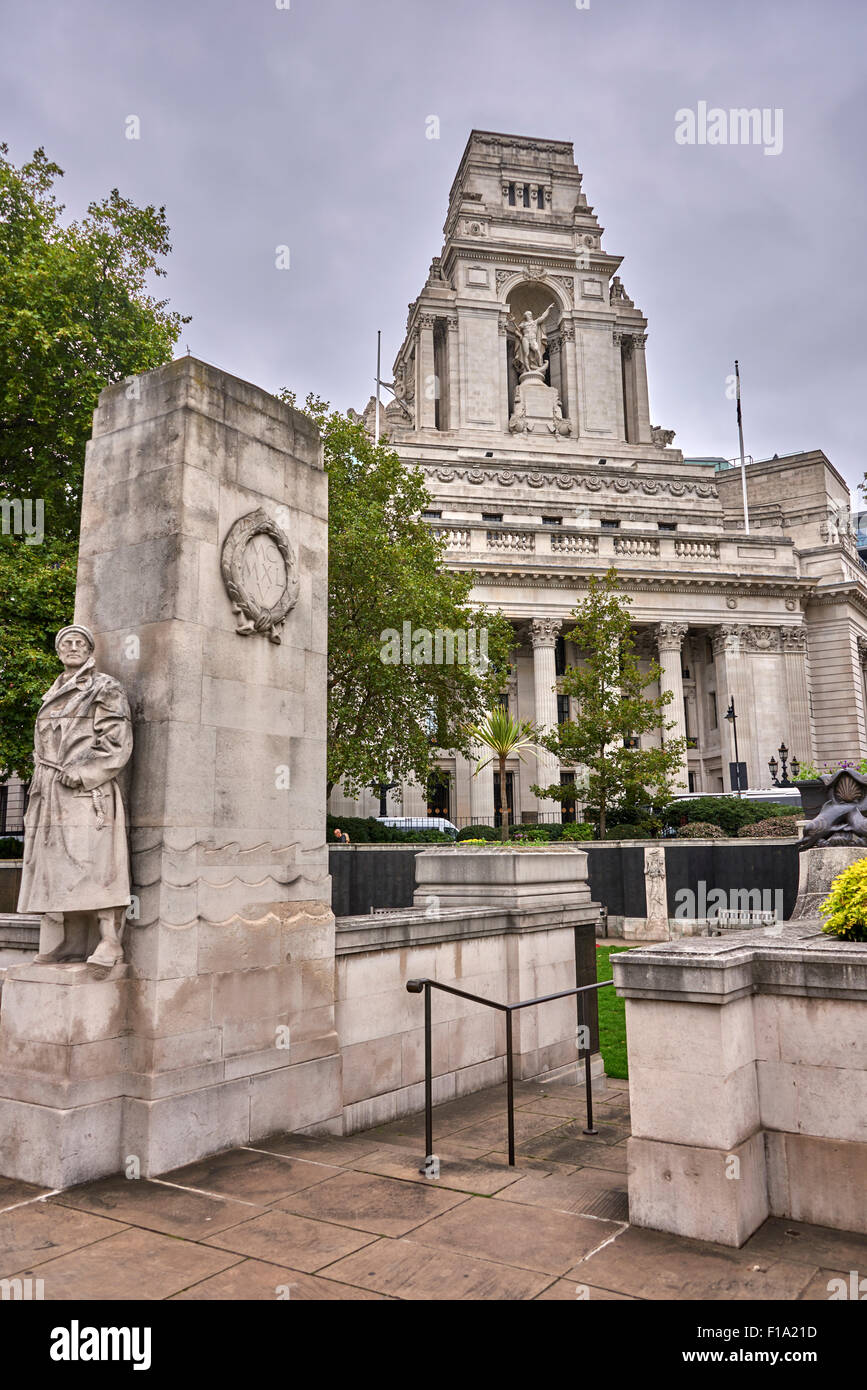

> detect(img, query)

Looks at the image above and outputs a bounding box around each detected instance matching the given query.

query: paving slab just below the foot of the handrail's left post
[278,1169,470,1236]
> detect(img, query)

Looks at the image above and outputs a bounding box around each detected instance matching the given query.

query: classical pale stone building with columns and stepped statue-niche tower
[332,131,867,823]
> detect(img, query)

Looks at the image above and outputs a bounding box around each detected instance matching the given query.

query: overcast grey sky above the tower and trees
[0,0,867,497]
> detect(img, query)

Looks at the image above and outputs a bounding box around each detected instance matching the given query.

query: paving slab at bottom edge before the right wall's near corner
[572,1228,814,1301]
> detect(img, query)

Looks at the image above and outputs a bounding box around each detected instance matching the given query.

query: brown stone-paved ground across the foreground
[0,1081,867,1301]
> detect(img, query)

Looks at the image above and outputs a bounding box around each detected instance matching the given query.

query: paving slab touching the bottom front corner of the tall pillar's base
[49,1176,258,1240]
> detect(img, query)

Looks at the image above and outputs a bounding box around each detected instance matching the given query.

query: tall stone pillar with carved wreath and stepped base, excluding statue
[0,357,342,1186]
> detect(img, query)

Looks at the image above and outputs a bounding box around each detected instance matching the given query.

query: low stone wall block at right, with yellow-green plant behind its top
[613,920,867,1245]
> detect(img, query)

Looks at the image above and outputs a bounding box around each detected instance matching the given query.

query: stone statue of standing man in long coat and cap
[18,623,132,970]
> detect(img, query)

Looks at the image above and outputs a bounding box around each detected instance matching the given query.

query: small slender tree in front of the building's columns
[532,569,686,838]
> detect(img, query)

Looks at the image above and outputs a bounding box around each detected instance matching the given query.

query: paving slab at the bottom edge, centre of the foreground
[318,1239,550,1302]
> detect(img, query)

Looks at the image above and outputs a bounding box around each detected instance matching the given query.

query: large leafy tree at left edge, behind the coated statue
[0,145,189,780]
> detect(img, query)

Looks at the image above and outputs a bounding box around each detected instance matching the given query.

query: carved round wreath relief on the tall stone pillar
[221,507,299,642]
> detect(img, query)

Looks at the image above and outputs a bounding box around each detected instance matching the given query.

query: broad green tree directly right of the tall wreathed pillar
[281,391,514,796]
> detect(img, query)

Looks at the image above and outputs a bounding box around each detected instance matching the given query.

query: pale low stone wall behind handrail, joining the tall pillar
[336,906,602,1134]
